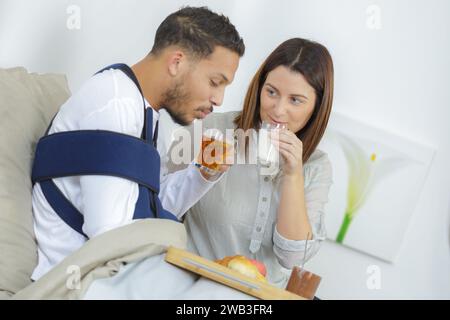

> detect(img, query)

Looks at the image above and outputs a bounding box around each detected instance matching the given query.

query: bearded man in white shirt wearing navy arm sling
[32,7,245,280]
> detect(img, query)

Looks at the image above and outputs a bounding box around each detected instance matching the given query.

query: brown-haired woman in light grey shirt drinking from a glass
[169,38,333,287]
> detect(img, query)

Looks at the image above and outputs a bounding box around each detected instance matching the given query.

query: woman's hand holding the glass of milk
[271,129,303,176]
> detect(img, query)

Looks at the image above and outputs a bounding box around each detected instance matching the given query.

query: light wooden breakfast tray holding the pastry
[165,247,306,300]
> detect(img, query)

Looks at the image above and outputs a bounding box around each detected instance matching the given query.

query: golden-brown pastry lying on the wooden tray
[215,255,266,281]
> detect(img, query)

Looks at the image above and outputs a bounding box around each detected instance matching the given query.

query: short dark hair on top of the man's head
[151,7,245,58]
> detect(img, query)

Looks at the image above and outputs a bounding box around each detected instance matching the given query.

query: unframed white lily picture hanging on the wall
[319,113,434,262]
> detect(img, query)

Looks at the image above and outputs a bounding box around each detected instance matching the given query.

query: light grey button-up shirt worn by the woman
[169,112,332,288]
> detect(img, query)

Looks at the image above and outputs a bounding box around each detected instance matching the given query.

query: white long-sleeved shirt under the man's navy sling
[32,70,214,280]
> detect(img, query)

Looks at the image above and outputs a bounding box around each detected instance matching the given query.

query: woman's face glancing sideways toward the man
[260,66,316,133]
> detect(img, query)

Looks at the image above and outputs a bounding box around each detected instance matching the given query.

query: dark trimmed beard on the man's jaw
[162,81,191,126]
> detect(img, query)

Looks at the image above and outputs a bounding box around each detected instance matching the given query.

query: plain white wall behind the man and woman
[0,0,450,299]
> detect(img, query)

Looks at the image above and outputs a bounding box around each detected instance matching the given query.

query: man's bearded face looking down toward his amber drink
[162,46,239,126]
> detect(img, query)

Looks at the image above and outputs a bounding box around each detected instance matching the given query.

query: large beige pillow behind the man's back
[0,68,70,299]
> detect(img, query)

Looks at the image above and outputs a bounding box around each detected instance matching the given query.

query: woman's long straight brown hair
[234,38,334,163]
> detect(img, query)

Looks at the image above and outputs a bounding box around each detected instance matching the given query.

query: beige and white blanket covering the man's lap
[12,219,254,299]
